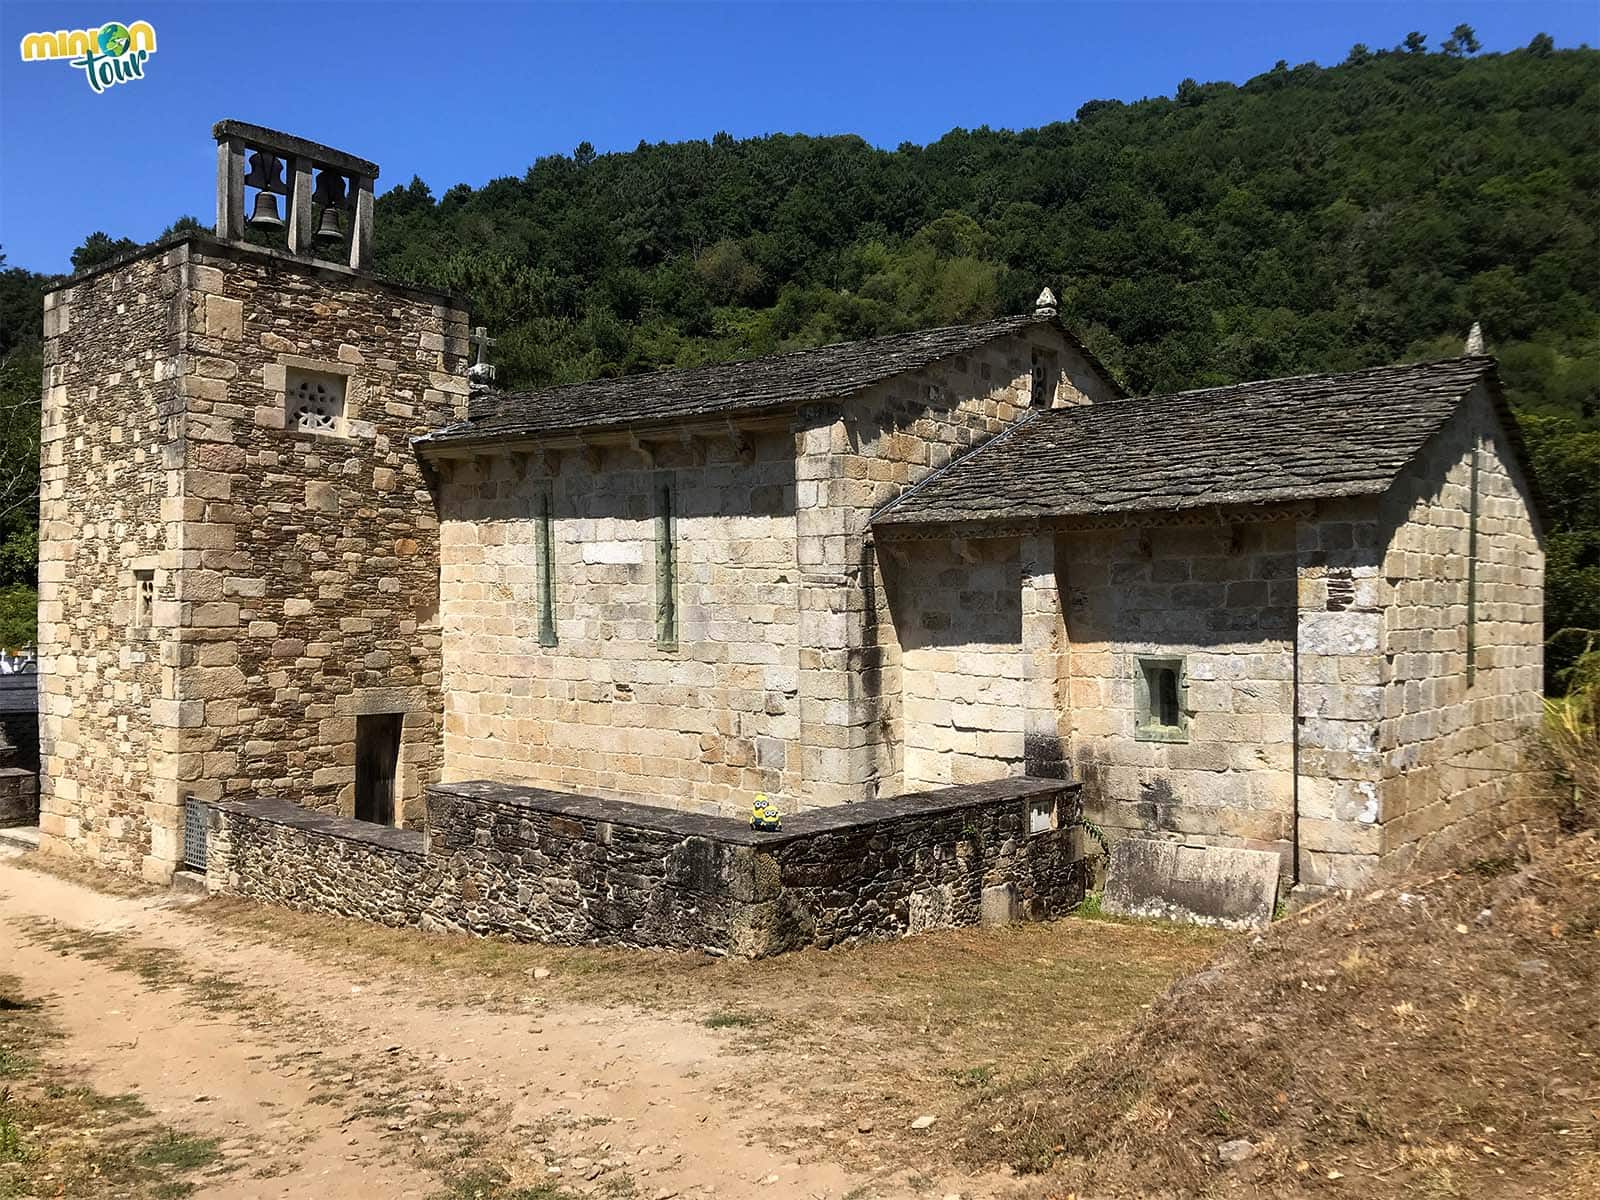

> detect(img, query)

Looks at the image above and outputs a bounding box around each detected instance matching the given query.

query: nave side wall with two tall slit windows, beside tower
[442,432,803,811]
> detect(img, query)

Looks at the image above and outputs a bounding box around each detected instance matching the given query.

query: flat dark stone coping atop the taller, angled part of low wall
[427,778,1082,846]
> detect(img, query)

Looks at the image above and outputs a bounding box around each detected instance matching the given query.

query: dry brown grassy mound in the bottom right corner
[965,832,1600,1198]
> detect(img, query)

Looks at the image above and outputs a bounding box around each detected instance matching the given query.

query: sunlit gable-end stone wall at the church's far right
[1376,389,1544,866]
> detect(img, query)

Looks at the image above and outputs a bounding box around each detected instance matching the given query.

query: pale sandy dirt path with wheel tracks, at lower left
[0,854,992,1200]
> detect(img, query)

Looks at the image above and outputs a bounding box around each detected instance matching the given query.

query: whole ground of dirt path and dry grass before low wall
[0,854,1219,1200]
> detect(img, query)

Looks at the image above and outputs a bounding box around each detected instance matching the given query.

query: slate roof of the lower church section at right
[872,357,1515,526]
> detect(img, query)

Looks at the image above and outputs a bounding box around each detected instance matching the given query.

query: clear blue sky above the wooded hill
[0,0,1600,272]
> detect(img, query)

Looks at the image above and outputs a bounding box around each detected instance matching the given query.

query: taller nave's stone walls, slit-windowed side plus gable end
[438,326,1110,811]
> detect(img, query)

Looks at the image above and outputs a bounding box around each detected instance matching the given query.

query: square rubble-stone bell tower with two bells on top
[38,120,470,880]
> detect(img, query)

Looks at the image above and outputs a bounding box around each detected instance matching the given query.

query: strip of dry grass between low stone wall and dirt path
[194,899,1229,1168]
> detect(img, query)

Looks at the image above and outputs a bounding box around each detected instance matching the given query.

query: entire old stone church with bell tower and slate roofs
[38,122,1542,941]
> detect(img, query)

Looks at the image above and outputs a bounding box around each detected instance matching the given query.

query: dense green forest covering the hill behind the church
[0,26,1600,683]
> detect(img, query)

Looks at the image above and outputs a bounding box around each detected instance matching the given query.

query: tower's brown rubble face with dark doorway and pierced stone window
[178,243,467,824]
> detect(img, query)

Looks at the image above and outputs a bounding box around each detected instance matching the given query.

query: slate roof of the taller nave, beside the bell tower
[419,315,1110,448]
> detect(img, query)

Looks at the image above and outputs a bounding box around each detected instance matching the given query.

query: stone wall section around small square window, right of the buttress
[1054,520,1294,867]
